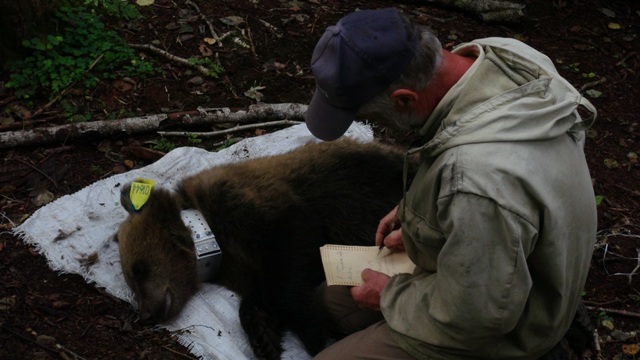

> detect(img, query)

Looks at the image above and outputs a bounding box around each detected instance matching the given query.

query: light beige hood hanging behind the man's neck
[420,38,597,156]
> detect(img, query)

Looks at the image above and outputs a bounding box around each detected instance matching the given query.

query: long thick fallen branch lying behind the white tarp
[0,103,307,149]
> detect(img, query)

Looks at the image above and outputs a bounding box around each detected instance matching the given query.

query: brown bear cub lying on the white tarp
[117,140,415,359]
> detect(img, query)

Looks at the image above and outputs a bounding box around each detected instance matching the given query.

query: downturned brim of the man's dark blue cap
[304,89,358,141]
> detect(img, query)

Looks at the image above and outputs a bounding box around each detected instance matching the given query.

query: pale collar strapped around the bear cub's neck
[180,209,222,282]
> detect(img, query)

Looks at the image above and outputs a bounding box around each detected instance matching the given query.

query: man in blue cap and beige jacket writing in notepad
[306,9,596,360]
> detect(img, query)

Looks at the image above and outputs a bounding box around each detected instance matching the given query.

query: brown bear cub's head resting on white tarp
[116,184,199,323]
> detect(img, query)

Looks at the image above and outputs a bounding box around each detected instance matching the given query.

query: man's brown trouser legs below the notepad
[314,285,414,360]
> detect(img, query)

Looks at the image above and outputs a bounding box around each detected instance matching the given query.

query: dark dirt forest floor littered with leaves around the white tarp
[0,0,640,359]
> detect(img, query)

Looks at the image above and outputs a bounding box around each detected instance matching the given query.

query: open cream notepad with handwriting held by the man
[320,245,415,286]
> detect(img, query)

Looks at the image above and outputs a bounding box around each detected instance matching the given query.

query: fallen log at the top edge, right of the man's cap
[406,0,525,23]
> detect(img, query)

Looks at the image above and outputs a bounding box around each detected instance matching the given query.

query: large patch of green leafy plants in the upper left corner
[6,6,153,98]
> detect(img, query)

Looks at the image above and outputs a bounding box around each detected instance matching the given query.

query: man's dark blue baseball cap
[305,8,417,140]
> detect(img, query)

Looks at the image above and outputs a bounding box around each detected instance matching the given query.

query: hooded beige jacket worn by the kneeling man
[381,38,596,360]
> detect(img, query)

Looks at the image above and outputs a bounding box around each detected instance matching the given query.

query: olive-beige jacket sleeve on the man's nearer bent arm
[381,192,537,350]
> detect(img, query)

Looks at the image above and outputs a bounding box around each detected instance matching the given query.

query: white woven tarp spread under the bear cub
[15,123,373,360]
